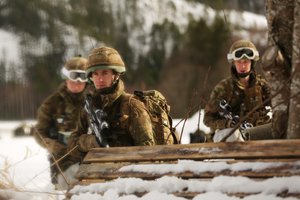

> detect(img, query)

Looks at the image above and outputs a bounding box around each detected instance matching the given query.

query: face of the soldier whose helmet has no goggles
[92,69,116,89]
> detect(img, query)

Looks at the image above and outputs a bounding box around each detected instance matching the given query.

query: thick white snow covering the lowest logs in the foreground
[70,176,300,200]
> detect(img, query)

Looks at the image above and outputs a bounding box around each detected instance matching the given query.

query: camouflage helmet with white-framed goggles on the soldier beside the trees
[227,40,259,63]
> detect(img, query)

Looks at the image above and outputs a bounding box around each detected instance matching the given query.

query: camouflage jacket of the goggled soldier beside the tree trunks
[204,71,271,132]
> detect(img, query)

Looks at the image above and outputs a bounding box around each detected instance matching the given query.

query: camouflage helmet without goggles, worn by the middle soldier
[87,47,126,77]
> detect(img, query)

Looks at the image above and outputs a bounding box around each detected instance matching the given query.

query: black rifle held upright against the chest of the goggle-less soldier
[84,94,109,148]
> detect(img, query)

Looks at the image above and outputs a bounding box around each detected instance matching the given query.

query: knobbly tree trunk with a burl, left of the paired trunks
[262,0,294,138]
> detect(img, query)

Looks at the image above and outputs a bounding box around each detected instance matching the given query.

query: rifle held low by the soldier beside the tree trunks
[219,99,253,140]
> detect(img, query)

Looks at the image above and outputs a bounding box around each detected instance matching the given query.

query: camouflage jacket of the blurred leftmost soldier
[33,82,83,169]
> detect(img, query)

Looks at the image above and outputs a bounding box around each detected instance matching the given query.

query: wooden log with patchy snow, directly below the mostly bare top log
[77,161,300,180]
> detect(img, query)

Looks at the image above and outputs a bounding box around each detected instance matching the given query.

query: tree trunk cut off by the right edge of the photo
[287,0,300,139]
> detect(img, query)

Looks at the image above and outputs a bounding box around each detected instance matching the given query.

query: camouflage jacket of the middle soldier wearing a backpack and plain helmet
[69,80,155,161]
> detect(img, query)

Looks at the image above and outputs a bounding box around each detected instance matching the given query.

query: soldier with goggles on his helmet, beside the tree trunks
[204,40,271,142]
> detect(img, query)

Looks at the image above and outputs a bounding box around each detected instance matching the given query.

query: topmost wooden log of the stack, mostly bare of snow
[83,140,300,164]
